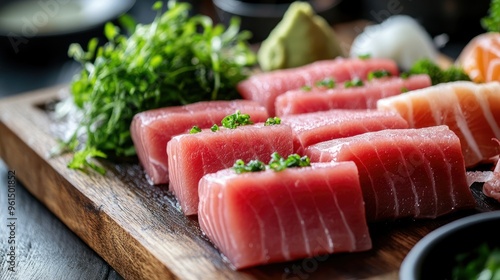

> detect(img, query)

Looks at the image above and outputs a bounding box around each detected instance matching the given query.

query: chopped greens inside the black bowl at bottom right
[452,243,500,280]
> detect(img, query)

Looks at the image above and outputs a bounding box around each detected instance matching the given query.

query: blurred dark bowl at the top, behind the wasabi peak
[213,0,341,43]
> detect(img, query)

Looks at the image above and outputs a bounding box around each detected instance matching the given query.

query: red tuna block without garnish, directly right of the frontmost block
[305,125,475,222]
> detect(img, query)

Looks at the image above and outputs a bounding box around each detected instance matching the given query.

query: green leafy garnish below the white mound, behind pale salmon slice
[402,59,470,85]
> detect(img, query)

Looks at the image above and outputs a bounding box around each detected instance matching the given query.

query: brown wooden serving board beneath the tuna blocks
[0,86,500,279]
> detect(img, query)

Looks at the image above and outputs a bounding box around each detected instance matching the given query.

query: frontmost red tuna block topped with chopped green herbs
[198,162,372,269]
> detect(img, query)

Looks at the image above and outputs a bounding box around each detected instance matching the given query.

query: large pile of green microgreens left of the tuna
[59,1,256,172]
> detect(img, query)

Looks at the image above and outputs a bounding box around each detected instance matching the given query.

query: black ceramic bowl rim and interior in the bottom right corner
[399,211,500,280]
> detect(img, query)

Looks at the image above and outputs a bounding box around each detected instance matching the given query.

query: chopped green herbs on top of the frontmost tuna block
[233,152,311,174]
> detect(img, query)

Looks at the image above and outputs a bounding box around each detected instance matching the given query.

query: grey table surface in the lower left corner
[0,161,122,280]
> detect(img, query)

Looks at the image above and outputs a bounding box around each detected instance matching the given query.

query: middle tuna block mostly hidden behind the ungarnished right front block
[281,110,408,154]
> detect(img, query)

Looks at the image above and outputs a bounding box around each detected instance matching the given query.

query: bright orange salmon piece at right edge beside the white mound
[457,32,500,83]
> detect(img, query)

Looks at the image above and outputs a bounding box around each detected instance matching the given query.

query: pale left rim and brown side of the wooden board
[0,87,252,279]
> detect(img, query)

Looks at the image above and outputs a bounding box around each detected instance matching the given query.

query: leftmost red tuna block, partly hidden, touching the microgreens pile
[130,100,268,184]
